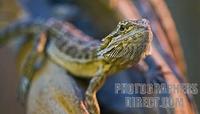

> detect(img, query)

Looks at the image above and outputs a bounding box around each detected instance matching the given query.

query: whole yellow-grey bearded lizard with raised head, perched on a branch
[0,19,152,114]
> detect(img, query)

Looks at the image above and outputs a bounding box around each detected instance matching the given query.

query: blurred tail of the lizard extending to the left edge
[0,20,44,45]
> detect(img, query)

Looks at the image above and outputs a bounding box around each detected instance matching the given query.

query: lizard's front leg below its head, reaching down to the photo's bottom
[85,67,107,114]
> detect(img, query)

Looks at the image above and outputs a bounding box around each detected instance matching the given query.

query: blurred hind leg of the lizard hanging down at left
[17,35,44,104]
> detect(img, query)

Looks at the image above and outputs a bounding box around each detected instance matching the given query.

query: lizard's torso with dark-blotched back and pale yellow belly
[47,20,104,78]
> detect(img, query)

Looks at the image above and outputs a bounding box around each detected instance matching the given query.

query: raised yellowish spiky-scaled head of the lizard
[97,19,152,64]
